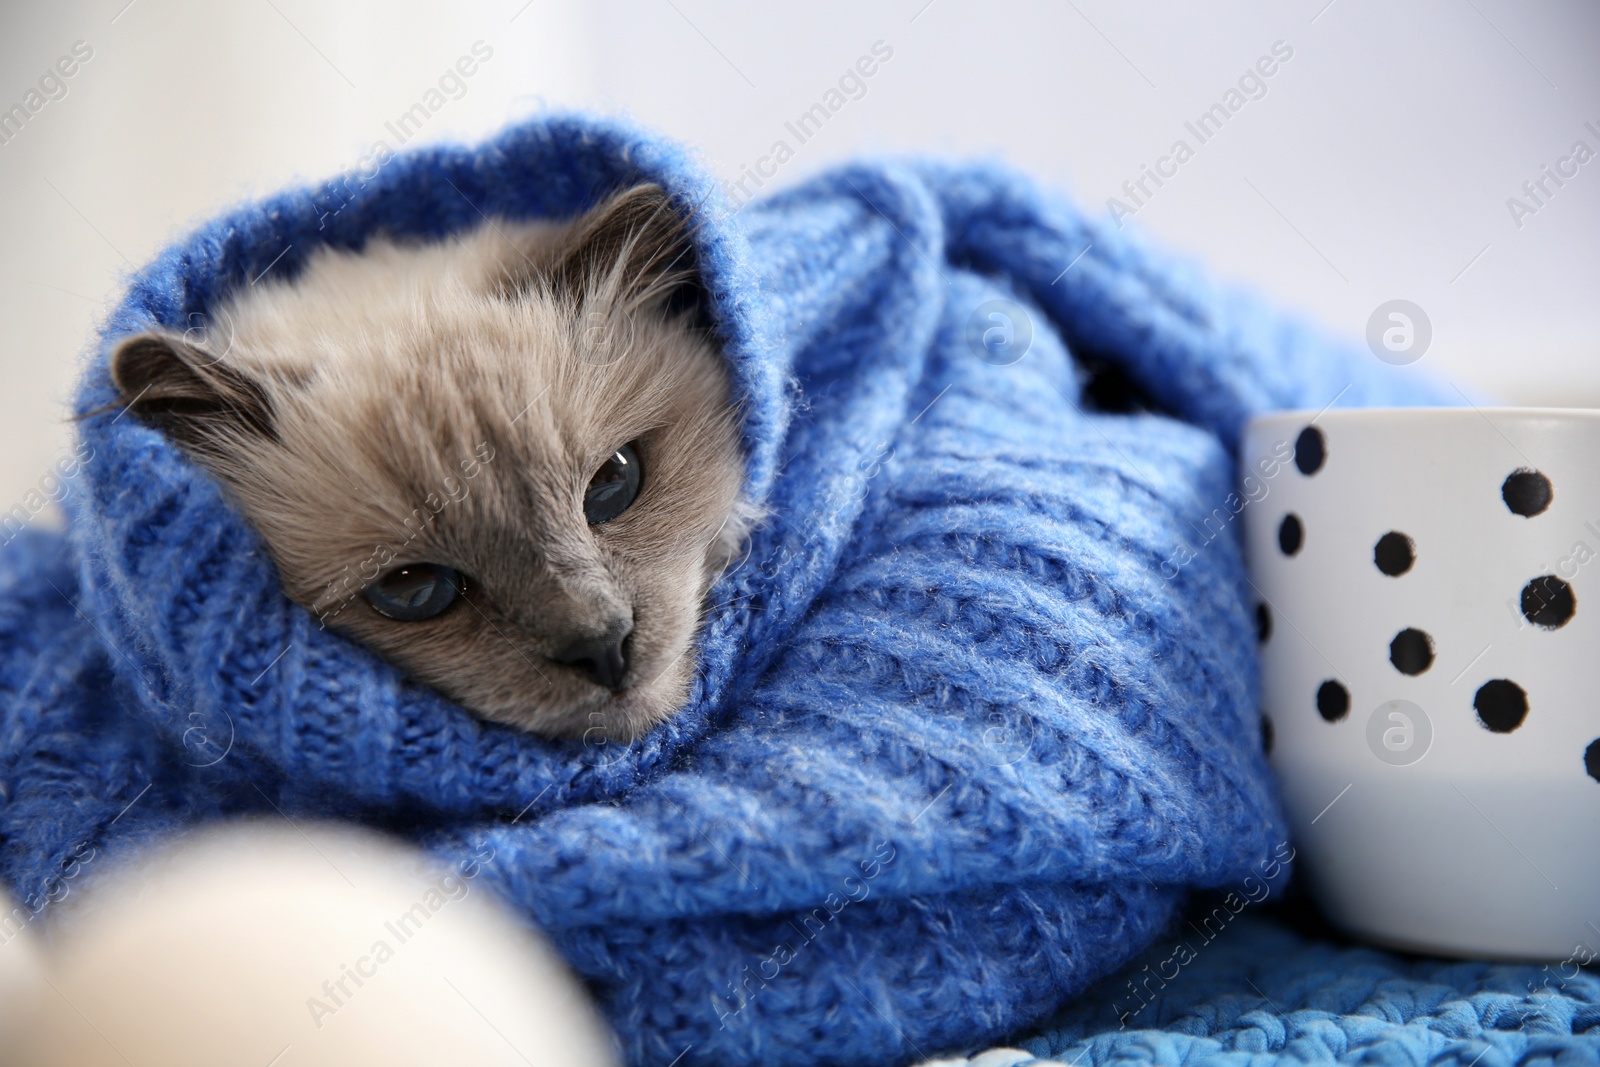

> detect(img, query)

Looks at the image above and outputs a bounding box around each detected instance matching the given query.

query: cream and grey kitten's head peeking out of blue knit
[110,186,755,741]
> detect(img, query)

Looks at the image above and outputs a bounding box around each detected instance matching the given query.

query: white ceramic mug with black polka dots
[1240,408,1600,963]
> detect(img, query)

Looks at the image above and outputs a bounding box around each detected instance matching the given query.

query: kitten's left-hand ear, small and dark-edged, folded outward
[110,331,277,448]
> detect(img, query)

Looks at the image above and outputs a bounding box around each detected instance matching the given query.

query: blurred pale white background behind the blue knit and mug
[0,0,1600,510]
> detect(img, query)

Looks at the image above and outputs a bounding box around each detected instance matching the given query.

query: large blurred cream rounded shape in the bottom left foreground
[0,824,616,1067]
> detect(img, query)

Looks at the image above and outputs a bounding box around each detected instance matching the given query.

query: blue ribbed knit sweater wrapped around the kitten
[0,117,1435,1067]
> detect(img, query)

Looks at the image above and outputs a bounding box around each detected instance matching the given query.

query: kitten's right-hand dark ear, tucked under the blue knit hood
[550,184,699,310]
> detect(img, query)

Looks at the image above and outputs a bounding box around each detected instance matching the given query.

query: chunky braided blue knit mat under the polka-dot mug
[947,915,1600,1067]
